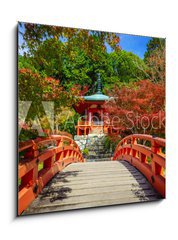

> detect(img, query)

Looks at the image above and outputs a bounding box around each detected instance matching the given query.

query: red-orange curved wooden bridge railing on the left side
[18,135,84,215]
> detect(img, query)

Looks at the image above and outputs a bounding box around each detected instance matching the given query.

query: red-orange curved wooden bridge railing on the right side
[113,134,166,197]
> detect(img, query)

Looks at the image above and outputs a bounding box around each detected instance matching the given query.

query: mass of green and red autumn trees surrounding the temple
[18,23,165,143]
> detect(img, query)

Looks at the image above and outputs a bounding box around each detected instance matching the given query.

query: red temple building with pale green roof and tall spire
[74,75,115,136]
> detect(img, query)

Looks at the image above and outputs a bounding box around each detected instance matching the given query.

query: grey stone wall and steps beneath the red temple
[74,134,113,161]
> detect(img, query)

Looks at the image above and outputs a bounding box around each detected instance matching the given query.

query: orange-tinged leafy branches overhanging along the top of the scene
[19,23,120,61]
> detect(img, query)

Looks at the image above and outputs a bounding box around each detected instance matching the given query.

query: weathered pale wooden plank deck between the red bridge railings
[24,161,160,214]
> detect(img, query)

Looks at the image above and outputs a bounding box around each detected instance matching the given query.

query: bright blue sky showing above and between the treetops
[19,23,151,59]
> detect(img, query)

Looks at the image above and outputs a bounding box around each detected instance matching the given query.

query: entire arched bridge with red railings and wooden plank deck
[18,134,165,215]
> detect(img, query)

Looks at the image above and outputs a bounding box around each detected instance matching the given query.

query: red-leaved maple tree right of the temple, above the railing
[107,80,165,136]
